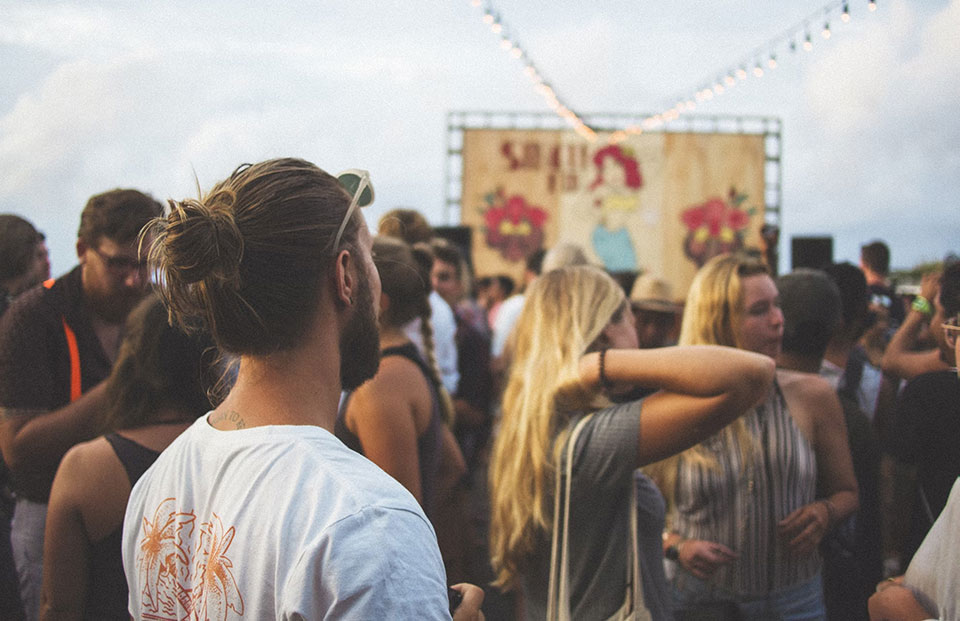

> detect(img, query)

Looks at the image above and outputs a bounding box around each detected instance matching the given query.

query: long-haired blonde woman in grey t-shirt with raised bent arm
[490,266,773,619]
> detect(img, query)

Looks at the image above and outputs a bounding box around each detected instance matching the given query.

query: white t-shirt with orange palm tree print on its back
[123,416,450,619]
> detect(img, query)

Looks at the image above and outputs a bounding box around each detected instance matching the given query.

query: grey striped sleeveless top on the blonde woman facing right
[671,383,821,595]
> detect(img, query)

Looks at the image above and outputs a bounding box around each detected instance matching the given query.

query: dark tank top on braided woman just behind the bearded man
[334,343,443,519]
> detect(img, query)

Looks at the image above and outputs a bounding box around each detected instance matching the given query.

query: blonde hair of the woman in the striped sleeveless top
[644,253,770,506]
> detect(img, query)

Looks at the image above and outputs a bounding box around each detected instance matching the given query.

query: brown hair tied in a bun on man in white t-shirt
[150,158,361,355]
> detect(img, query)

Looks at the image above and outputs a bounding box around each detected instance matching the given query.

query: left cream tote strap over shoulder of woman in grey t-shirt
[547,415,592,621]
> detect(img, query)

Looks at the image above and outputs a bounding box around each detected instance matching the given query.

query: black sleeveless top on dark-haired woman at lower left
[83,433,160,620]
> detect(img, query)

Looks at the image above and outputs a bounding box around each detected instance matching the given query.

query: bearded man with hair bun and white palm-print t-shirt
[122,158,483,619]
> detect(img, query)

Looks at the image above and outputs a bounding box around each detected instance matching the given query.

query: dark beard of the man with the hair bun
[340,274,380,391]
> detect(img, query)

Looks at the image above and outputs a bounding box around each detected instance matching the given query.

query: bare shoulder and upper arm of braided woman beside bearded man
[346,356,429,502]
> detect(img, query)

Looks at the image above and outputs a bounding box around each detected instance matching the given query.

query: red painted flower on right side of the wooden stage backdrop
[680,188,756,267]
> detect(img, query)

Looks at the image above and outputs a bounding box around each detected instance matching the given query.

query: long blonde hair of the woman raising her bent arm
[490,266,629,588]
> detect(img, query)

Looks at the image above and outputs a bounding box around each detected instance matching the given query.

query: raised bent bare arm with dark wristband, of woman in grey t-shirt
[580,345,774,467]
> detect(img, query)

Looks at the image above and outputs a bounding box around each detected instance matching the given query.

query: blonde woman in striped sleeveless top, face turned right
[648,255,857,619]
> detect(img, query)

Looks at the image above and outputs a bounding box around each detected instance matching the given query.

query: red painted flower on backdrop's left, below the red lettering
[484,188,547,262]
